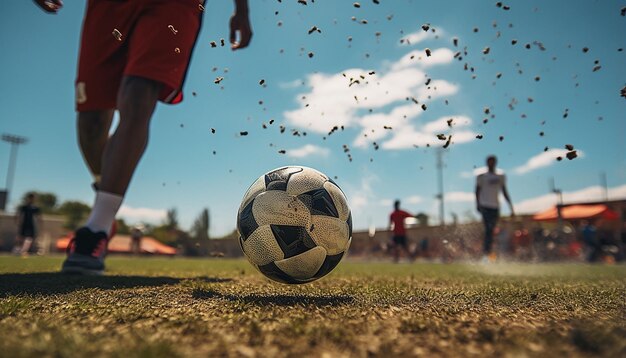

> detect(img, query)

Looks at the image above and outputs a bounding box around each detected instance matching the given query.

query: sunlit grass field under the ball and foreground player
[0,256,626,357]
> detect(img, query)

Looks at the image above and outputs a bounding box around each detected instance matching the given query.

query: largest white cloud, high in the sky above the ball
[284,32,476,150]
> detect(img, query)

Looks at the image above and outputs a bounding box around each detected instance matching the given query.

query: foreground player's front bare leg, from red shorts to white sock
[100,76,161,196]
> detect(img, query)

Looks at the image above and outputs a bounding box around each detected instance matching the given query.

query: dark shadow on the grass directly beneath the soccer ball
[192,289,354,307]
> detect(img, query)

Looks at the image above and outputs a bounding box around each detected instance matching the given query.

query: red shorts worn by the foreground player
[76,0,204,112]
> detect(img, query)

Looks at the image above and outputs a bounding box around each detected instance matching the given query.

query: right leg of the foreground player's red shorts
[124,0,203,103]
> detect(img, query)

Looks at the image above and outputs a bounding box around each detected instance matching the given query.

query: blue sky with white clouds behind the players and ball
[0,0,626,235]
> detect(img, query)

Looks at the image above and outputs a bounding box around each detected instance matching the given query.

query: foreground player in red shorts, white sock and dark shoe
[35,0,252,274]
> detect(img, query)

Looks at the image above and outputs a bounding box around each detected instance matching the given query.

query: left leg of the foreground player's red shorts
[76,0,136,112]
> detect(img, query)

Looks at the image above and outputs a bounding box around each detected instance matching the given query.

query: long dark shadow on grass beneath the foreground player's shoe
[0,272,232,298]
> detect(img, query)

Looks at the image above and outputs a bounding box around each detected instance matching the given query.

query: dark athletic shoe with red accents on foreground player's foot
[61,227,109,275]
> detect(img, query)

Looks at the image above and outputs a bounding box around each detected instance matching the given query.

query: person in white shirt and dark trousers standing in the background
[476,155,515,257]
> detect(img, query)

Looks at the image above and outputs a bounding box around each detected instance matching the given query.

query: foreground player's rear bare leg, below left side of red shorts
[77,109,114,178]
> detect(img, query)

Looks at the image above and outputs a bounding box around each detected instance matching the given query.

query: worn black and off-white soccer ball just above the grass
[237,166,352,284]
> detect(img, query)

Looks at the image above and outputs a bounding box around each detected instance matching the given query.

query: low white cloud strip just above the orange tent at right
[515,184,626,213]
